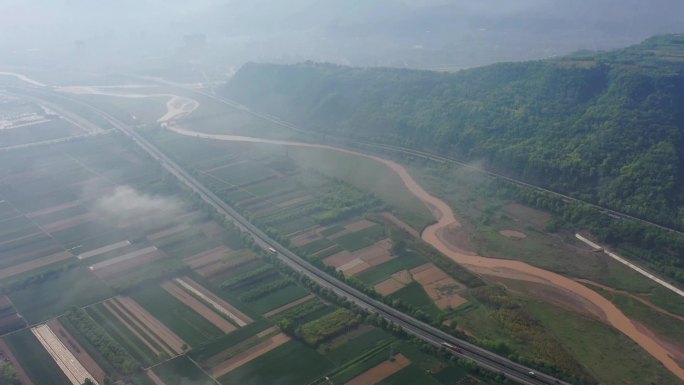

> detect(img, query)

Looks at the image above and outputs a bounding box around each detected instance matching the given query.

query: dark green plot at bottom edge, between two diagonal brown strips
[218,340,333,385]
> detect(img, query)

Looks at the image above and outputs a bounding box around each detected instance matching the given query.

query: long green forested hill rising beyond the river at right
[222,35,684,229]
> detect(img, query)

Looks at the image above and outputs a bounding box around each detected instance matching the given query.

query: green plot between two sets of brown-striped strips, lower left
[131,286,223,347]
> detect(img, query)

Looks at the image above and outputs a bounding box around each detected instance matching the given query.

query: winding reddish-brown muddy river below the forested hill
[68,85,684,380]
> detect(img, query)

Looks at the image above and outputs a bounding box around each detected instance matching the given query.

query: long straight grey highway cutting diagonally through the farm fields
[32,88,569,385]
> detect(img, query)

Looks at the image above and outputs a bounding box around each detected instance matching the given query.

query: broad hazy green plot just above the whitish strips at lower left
[8,266,114,323]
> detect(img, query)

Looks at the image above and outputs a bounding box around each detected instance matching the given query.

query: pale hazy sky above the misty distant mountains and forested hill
[0,0,684,70]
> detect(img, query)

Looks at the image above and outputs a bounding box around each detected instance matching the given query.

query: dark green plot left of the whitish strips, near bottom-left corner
[3,329,71,385]
